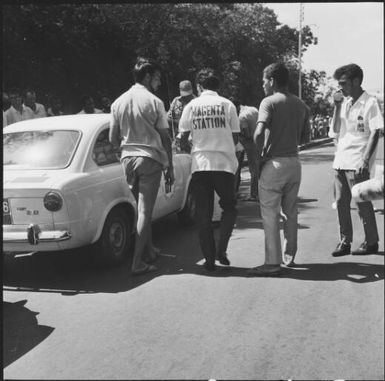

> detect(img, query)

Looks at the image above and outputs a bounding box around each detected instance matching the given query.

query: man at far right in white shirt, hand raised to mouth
[329,64,384,257]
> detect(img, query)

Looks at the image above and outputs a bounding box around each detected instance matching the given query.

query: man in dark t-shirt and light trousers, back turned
[249,63,309,276]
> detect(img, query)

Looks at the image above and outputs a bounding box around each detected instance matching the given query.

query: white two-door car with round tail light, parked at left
[3,114,194,264]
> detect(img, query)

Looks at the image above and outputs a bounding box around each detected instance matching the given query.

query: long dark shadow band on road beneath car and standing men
[3,243,384,296]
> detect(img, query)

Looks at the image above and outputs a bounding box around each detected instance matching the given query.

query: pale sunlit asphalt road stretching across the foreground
[3,144,384,380]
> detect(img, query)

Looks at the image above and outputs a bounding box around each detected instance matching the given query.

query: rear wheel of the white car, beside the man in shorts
[97,207,133,266]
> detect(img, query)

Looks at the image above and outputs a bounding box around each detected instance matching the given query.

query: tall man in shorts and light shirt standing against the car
[110,58,174,275]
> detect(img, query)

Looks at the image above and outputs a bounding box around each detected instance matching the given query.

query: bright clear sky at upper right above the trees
[264,2,384,93]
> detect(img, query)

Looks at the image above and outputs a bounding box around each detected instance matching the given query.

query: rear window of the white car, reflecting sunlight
[3,130,80,169]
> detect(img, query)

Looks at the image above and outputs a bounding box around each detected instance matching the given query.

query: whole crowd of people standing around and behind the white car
[3,58,384,276]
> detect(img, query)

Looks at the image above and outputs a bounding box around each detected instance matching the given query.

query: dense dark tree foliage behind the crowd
[3,3,320,111]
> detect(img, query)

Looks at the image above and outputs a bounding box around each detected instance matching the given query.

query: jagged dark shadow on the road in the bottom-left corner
[3,300,54,368]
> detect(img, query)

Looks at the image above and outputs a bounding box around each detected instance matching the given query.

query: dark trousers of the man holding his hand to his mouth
[335,170,378,245]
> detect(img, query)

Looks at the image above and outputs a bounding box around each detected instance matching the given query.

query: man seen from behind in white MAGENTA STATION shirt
[179,68,240,271]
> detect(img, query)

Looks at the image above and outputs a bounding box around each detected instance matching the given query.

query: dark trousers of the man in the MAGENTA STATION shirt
[192,171,237,263]
